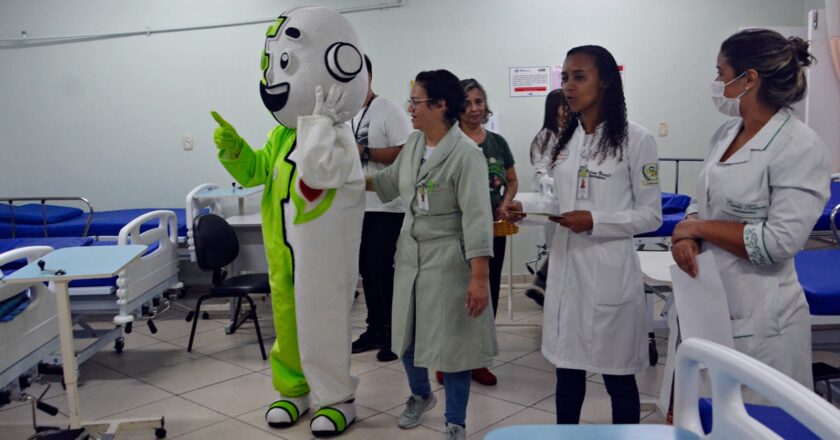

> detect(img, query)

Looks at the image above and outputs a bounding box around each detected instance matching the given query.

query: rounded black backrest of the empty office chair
[193,214,239,272]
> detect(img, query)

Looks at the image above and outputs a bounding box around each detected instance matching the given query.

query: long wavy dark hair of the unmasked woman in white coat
[551,45,628,166]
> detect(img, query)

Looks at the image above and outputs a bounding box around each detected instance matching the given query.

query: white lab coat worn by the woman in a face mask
[687,110,830,388]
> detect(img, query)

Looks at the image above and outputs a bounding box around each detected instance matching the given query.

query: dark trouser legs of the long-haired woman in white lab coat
[554,368,641,425]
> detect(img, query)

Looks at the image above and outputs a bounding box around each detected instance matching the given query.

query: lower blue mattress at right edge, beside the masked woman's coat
[793,249,840,315]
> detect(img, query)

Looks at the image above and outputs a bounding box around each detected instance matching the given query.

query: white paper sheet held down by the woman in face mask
[671,251,734,348]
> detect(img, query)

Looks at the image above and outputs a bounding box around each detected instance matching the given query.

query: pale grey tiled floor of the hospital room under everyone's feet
[0,292,836,440]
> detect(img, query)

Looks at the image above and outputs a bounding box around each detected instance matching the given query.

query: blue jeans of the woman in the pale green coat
[402,343,470,427]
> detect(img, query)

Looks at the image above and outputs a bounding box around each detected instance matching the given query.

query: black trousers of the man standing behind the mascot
[359,212,404,338]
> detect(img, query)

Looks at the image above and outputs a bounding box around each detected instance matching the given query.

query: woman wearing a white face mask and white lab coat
[672,29,830,388]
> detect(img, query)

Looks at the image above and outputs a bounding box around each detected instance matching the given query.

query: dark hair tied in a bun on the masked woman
[720,29,815,109]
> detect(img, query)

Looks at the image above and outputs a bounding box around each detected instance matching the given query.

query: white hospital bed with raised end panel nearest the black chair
[0,210,180,363]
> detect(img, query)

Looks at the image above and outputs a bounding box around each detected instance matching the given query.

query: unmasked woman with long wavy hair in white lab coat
[510,46,662,423]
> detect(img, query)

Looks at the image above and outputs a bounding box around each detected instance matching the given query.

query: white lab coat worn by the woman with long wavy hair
[542,122,662,375]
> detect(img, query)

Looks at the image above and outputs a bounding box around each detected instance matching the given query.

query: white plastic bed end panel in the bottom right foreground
[674,338,840,439]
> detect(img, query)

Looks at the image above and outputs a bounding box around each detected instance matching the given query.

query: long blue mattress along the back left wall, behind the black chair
[0,208,187,238]
